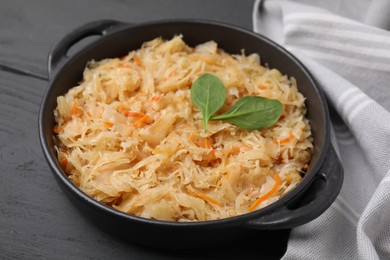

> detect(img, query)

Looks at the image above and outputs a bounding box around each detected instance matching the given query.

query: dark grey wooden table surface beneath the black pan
[0,0,287,259]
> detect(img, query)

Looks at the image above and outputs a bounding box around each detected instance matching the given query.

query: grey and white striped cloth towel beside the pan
[253,0,390,259]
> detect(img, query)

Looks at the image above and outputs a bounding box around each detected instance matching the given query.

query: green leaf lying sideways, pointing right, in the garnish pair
[210,96,283,130]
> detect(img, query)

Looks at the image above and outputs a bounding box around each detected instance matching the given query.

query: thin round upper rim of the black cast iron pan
[38,19,330,227]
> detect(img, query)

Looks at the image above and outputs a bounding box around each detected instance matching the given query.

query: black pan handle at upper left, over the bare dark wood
[48,20,129,78]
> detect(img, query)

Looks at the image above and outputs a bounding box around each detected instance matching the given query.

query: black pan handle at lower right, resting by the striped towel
[242,145,344,230]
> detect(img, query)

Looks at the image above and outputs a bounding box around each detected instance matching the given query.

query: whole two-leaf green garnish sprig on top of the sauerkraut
[191,73,283,132]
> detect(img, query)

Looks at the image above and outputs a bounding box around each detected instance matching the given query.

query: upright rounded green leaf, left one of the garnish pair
[191,73,226,132]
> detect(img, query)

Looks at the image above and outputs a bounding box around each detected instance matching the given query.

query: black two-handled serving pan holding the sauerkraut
[39,20,343,248]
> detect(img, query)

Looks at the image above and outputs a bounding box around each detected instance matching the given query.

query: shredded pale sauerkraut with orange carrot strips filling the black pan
[53,35,313,221]
